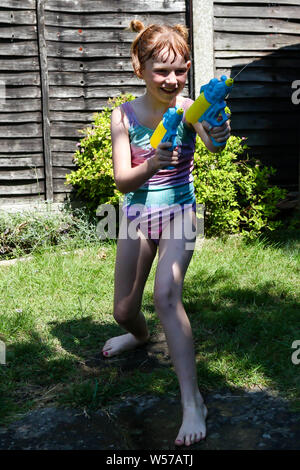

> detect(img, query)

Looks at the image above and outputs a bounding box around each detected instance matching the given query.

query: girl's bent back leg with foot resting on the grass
[102,216,157,357]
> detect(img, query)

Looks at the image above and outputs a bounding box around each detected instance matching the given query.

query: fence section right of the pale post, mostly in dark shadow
[214,0,300,195]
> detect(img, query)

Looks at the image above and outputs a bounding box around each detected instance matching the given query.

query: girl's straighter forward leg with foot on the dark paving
[154,211,207,445]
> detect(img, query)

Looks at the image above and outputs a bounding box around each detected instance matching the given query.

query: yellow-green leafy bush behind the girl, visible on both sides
[66,94,286,238]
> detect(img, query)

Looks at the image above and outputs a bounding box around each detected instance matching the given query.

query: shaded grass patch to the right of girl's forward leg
[184,252,300,398]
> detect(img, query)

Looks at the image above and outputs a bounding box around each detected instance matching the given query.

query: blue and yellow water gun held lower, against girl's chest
[150,106,183,170]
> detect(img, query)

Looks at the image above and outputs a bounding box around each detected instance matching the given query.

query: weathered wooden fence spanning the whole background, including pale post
[0,0,300,209]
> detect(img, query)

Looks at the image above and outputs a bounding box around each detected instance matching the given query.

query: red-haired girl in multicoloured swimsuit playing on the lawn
[102,20,230,446]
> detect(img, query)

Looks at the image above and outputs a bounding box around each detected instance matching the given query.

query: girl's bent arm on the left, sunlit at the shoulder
[110,108,178,194]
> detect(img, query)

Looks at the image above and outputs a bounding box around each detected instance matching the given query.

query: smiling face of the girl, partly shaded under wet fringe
[142,49,191,104]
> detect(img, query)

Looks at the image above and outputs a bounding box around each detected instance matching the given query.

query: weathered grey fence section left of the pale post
[0,0,189,207]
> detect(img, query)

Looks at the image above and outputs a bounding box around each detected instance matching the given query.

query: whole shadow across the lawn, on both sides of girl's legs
[0,229,300,419]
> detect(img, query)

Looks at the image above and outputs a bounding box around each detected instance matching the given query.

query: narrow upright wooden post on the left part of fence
[36,0,53,202]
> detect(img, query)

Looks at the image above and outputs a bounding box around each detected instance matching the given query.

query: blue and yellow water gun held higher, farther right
[185,75,234,147]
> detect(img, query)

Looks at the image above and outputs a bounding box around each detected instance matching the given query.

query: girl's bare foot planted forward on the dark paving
[175,400,207,446]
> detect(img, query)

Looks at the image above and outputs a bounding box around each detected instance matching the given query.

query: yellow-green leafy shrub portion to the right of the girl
[194,136,287,238]
